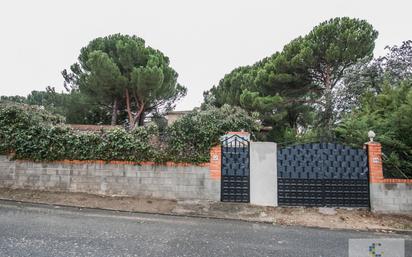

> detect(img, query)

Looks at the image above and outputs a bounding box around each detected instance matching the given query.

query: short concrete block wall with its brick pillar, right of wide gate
[367,142,412,214]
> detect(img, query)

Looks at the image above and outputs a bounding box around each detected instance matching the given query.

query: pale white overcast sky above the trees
[0,0,412,110]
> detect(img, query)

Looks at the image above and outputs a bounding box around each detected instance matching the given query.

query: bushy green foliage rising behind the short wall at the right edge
[336,80,412,177]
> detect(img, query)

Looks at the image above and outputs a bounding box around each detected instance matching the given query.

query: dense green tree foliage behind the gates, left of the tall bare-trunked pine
[204,50,311,142]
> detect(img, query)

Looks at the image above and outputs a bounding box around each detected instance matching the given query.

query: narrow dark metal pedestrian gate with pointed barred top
[221,135,250,202]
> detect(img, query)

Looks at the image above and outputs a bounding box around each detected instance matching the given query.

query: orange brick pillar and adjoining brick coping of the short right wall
[366,142,412,184]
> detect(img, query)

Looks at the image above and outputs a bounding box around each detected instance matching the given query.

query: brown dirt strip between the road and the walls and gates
[0,189,412,233]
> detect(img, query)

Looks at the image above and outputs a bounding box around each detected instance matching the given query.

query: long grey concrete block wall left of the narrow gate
[0,156,220,201]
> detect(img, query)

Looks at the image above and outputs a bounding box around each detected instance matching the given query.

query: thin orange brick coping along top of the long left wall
[10,160,210,167]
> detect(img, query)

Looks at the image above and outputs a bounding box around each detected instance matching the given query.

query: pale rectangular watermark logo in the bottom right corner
[349,238,405,257]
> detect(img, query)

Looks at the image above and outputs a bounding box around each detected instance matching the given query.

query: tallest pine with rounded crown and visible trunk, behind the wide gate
[282,17,378,136]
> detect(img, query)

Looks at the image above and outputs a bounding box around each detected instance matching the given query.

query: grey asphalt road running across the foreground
[0,201,412,257]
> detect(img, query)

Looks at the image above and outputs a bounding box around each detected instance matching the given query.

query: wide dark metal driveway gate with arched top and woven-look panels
[277,143,369,207]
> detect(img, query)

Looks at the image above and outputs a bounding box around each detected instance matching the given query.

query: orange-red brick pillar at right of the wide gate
[366,142,383,183]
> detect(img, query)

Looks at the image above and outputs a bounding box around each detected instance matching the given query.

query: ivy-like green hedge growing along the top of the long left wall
[0,103,258,163]
